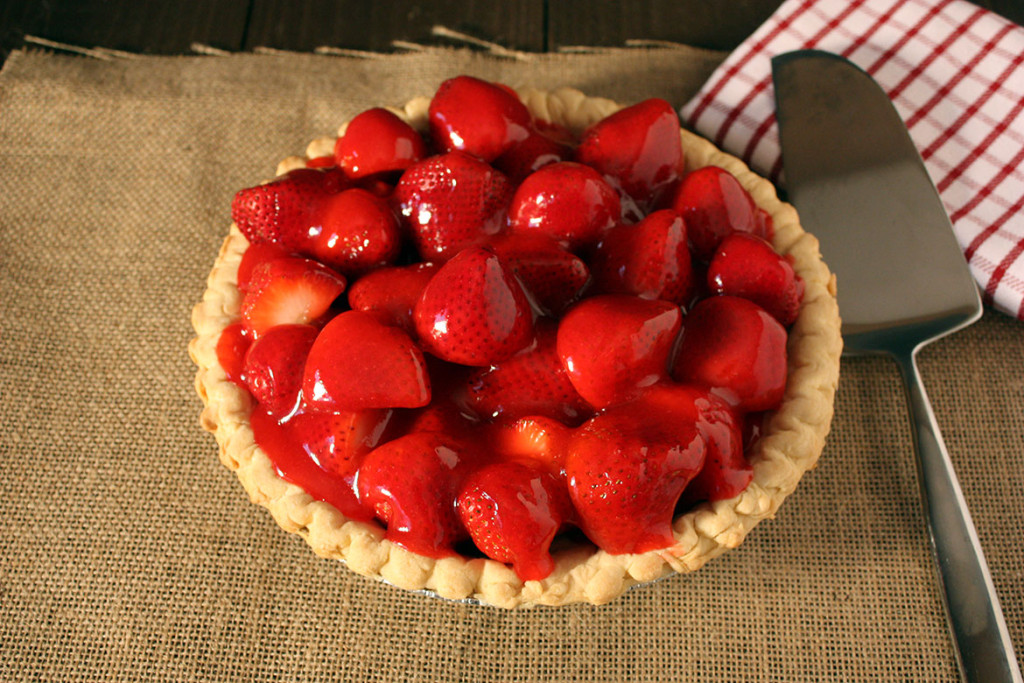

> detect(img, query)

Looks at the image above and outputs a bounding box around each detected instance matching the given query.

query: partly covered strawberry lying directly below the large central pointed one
[464,323,589,424]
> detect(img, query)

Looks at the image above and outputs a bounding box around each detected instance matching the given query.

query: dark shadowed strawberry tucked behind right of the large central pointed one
[487,232,590,315]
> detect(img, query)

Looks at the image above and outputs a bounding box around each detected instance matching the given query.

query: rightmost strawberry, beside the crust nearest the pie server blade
[708,232,804,326]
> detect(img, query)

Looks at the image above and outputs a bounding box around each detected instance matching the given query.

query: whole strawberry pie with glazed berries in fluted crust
[189,76,841,607]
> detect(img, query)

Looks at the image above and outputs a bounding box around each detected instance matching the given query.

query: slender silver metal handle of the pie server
[894,349,1022,683]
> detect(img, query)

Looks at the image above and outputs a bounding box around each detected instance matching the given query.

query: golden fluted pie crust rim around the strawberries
[188,88,842,608]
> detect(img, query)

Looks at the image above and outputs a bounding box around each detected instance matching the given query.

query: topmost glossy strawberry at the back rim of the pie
[428,76,531,162]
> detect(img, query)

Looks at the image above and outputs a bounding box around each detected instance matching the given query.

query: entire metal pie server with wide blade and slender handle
[772,50,1021,683]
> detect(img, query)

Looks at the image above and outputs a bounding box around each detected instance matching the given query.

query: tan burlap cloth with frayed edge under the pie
[0,49,1024,681]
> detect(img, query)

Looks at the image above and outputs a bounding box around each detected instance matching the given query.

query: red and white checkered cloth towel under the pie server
[681,0,1024,319]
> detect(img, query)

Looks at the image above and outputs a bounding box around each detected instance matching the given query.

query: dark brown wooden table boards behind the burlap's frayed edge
[6,0,1024,58]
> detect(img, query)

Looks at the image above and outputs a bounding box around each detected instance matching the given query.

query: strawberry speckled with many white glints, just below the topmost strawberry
[394,152,514,261]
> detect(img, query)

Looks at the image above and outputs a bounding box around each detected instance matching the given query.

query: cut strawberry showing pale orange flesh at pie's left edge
[242,257,345,336]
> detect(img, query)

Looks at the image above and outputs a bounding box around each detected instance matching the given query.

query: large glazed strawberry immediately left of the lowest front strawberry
[356,432,480,557]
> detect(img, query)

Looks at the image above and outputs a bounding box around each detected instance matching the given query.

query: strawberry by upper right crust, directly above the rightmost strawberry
[671,166,771,261]
